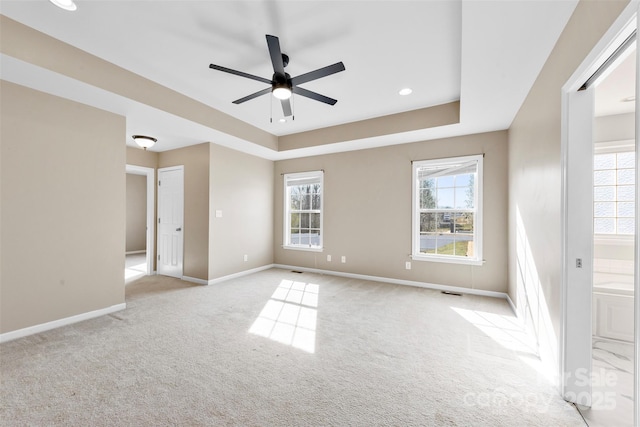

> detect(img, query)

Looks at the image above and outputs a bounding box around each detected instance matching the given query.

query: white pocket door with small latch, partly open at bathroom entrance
[563,87,594,406]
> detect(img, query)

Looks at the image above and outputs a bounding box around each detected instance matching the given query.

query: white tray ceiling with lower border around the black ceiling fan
[0,0,577,159]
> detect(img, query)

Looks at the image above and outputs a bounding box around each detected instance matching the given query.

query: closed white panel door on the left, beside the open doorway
[158,166,184,278]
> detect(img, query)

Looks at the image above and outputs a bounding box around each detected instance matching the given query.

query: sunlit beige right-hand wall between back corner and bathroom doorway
[509,0,627,378]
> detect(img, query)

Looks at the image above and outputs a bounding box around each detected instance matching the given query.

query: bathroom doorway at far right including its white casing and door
[560,4,640,426]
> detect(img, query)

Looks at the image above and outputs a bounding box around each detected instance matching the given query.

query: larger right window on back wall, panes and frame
[412,155,483,264]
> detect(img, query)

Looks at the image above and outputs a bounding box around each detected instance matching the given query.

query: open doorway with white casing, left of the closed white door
[125,165,155,283]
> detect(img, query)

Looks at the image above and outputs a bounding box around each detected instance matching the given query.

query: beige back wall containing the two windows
[274,131,507,292]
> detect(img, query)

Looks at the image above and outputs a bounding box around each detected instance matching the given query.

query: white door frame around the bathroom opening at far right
[559,0,640,425]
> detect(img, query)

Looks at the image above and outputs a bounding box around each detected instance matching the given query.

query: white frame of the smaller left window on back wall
[282,170,324,252]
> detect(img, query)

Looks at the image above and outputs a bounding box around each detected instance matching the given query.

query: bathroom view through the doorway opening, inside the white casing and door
[582,43,637,426]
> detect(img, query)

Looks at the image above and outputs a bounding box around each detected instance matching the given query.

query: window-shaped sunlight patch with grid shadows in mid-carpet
[249,280,320,353]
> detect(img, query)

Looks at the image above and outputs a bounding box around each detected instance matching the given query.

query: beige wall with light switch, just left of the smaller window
[209,144,273,279]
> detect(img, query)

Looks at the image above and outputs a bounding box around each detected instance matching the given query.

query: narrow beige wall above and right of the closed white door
[158,143,210,280]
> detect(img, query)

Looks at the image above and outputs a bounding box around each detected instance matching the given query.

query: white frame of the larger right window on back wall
[411,154,484,265]
